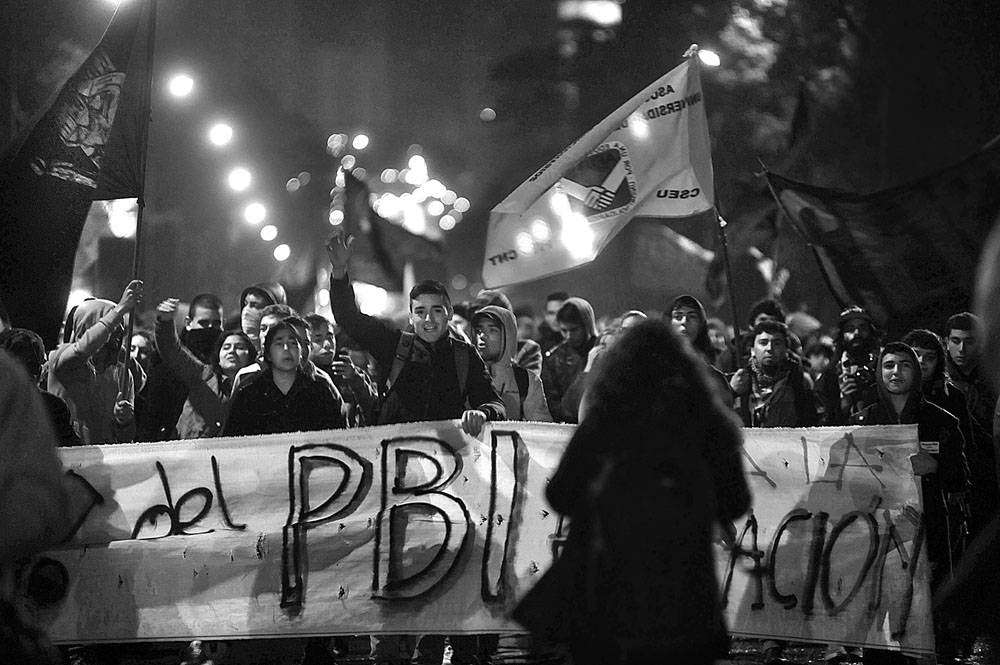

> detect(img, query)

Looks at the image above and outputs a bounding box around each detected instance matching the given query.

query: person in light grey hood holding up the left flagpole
[48,280,146,444]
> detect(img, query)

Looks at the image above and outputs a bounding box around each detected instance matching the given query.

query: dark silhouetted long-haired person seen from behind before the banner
[514,321,750,665]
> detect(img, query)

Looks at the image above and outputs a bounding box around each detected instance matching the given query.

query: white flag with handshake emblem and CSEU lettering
[483,56,715,288]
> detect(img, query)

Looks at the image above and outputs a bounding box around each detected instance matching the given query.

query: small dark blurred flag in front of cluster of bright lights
[344,171,441,292]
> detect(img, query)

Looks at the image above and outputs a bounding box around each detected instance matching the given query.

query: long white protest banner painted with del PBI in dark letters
[21,421,933,652]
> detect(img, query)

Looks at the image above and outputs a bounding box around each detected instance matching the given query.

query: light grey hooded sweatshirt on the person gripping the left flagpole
[48,299,146,445]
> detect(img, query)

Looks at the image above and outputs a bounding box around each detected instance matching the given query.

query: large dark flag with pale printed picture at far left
[0,0,155,346]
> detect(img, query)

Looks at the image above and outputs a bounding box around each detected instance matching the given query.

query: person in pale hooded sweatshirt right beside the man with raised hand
[472,305,552,422]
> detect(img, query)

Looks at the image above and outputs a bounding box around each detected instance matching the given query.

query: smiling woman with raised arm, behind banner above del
[156,298,253,439]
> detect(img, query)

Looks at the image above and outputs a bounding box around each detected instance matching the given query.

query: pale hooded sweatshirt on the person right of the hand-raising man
[472,305,552,422]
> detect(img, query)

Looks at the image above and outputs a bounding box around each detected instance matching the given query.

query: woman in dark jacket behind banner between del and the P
[223,321,344,436]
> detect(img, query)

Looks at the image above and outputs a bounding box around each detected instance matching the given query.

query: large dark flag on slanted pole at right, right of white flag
[767,141,1000,337]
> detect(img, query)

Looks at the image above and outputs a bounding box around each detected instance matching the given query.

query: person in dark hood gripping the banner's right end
[851,342,969,587]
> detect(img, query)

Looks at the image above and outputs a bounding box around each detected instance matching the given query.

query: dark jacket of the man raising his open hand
[330,277,506,424]
